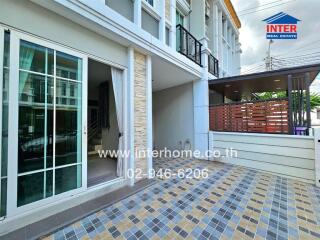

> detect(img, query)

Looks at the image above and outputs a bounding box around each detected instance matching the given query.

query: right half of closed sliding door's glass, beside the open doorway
[55,52,82,194]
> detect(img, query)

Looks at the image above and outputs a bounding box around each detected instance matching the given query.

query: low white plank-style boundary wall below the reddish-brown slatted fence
[209,132,316,183]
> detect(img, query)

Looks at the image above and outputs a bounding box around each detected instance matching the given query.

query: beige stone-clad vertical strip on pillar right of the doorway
[134,52,148,177]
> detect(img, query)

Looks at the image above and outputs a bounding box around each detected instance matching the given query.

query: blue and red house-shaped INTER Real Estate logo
[263,12,301,39]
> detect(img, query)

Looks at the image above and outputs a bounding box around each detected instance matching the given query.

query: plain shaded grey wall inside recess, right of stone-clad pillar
[153,83,194,150]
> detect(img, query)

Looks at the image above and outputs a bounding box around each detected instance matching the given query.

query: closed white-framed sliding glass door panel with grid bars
[9,33,86,214]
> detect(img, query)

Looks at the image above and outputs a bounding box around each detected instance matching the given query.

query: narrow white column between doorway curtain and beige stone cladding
[125,47,135,186]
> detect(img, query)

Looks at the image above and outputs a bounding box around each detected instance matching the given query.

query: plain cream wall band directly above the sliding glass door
[0,0,127,66]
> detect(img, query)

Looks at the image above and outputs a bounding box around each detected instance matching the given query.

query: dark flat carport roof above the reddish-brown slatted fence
[209,64,320,99]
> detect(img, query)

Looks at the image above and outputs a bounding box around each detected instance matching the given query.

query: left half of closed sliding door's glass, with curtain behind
[17,40,54,207]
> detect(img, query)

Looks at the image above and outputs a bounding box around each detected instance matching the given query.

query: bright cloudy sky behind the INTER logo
[231,0,320,81]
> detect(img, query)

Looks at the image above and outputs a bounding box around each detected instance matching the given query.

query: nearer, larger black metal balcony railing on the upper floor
[176,24,202,66]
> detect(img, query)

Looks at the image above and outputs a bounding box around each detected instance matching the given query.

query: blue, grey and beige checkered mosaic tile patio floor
[43,159,320,240]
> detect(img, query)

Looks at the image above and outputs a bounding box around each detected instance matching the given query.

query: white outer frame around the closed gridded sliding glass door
[6,30,88,217]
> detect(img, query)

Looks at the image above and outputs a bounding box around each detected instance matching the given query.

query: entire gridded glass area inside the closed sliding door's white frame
[18,41,82,206]
